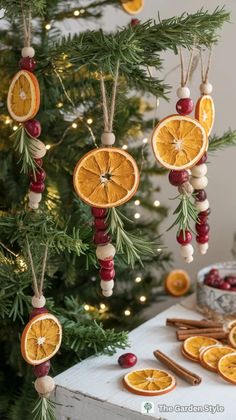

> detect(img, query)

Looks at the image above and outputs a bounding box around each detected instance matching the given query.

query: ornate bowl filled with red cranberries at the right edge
[197,262,236,319]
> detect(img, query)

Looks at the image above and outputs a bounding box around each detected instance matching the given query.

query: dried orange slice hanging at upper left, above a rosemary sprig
[7,70,40,122]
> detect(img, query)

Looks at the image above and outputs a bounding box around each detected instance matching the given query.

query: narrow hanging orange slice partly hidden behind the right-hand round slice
[195,95,215,136]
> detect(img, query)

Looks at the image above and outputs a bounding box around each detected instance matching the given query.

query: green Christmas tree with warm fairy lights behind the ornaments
[0,0,236,420]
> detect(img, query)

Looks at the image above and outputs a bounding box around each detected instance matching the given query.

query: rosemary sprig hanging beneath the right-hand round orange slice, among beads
[167,194,198,233]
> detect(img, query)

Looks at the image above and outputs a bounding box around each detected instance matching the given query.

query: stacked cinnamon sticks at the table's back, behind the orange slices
[166,318,228,341]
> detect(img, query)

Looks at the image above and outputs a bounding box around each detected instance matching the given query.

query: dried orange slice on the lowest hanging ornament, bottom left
[21,313,62,365]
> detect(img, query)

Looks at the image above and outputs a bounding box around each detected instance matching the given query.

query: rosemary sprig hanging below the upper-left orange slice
[10,125,37,174]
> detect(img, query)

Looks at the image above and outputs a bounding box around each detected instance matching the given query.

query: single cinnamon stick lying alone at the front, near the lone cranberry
[153,350,202,385]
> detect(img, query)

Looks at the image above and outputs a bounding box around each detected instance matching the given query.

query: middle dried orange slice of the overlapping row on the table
[200,346,235,372]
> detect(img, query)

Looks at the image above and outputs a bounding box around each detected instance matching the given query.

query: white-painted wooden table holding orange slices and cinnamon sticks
[55,296,236,420]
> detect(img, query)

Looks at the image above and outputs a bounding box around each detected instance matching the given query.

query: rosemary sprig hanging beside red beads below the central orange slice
[107,208,157,268]
